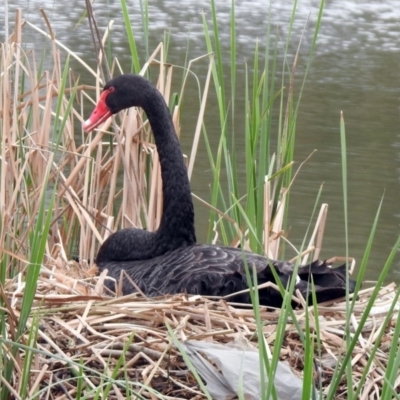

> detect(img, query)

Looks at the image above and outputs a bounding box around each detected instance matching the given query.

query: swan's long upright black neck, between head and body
[142,89,196,253]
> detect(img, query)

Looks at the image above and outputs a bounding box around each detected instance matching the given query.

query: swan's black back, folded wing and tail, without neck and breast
[99,245,353,307]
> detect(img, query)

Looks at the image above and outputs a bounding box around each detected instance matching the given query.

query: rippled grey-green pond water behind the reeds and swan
[6,0,400,282]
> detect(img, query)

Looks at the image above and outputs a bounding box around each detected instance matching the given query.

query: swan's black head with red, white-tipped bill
[83,74,156,132]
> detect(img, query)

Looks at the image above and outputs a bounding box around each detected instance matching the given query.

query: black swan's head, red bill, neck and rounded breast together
[84,74,196,264]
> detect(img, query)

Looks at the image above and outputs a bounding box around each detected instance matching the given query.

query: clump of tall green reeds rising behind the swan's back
[203,1,324,256]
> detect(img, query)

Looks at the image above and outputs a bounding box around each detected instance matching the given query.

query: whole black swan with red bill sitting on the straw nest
[83,74,355,307]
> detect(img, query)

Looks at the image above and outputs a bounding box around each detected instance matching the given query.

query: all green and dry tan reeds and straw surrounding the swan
[0,0,400,400]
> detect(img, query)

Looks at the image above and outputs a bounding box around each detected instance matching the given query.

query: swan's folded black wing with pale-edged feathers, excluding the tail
[99,245,292,305]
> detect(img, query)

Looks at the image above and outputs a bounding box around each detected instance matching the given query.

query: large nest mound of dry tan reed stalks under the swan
[3,262,399,400]
